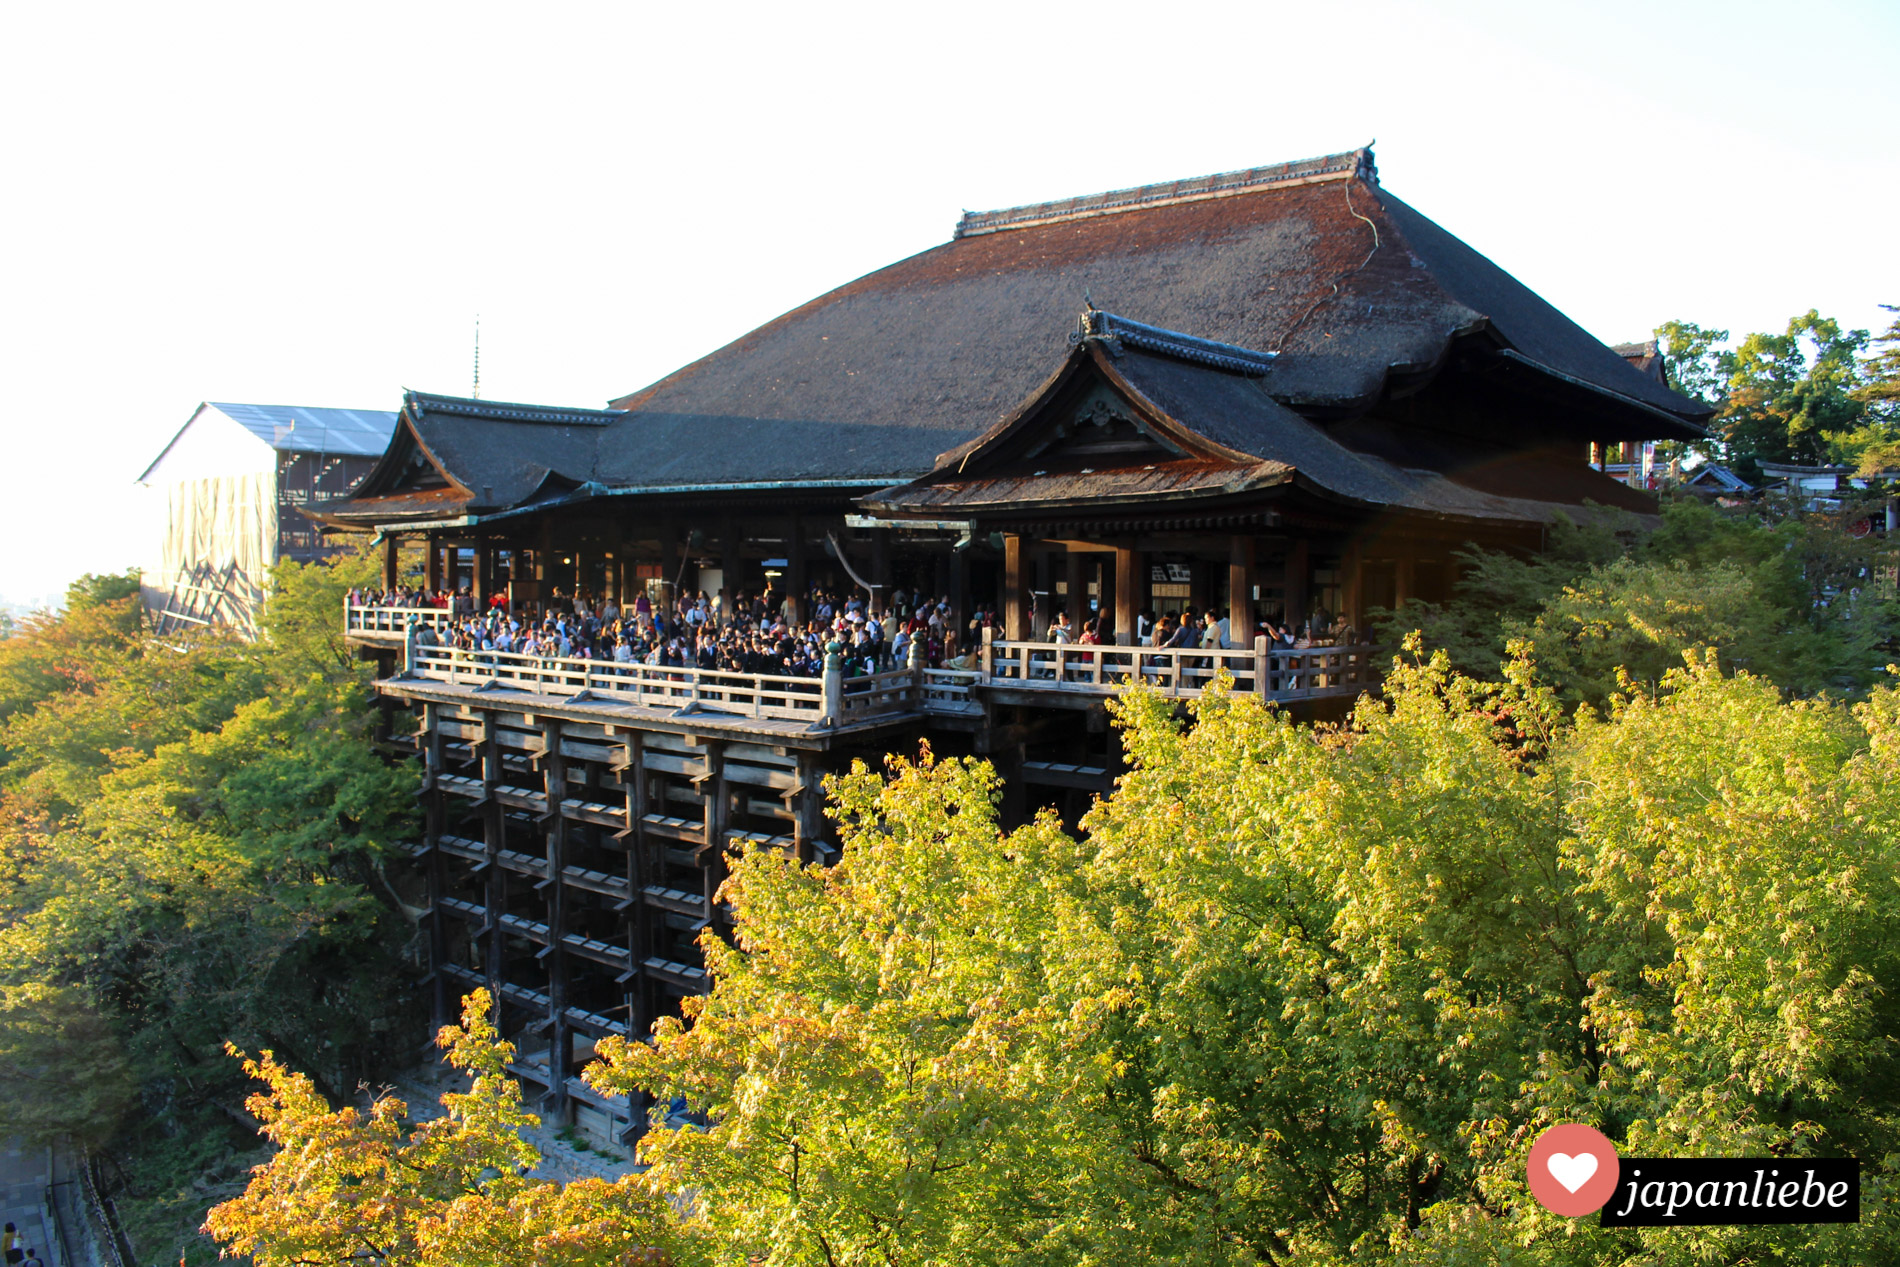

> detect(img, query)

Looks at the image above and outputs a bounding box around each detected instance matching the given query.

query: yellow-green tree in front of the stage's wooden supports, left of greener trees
[589,754,1170,1267]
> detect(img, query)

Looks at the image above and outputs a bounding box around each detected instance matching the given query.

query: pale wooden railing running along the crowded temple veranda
[357,608,1379,729]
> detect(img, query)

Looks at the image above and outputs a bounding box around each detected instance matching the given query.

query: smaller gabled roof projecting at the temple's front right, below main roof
[863,312,1655,522]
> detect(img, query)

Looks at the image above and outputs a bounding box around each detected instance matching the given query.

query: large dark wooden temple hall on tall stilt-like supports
[315,150,1706,1132]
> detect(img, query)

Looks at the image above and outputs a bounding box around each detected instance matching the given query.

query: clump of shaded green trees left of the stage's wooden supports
[0,558,414,1242]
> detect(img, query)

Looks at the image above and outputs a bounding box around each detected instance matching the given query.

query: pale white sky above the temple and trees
[0,0,1900,600]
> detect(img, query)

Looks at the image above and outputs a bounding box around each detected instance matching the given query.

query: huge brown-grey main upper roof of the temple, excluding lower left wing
[614,150,1708,453]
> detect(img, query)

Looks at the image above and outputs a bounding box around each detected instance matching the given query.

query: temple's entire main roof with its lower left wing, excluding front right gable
[323,150,1708,522]
